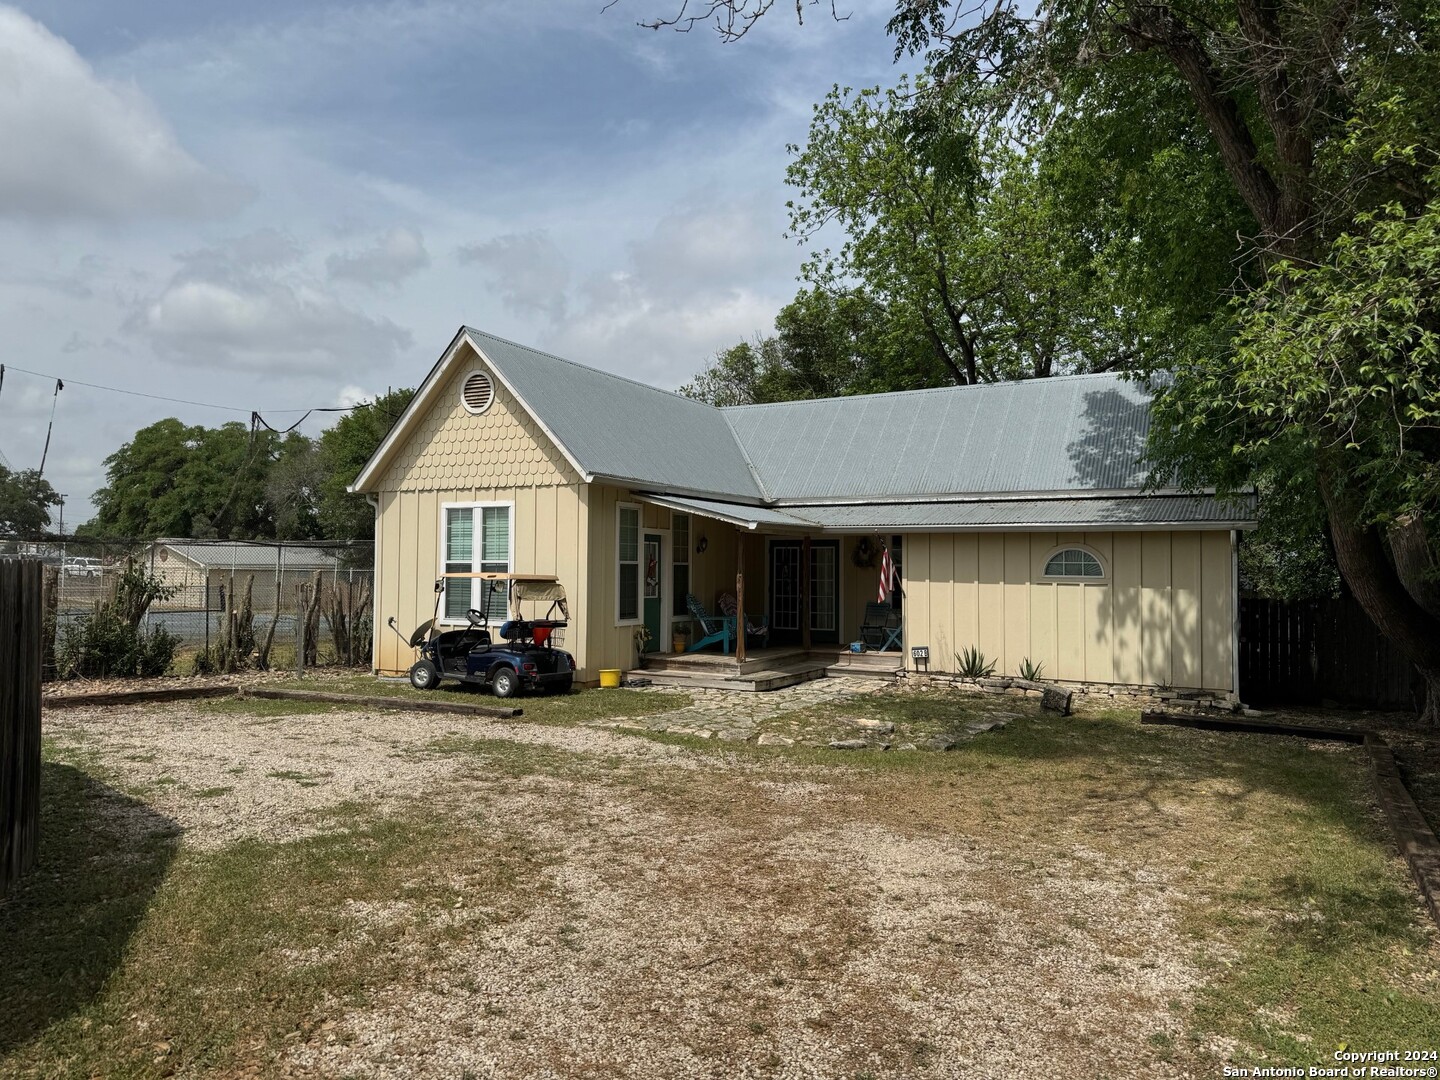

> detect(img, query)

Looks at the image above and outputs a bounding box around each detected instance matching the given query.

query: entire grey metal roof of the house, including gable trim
[354,327,1256,530]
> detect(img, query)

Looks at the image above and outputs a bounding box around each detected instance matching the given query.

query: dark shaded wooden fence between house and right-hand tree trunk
[1240,595,1417,708]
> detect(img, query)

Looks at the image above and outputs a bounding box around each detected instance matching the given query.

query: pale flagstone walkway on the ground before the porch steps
[588,675,890,743]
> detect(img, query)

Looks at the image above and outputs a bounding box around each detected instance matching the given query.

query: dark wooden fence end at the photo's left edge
[0,559,43,897]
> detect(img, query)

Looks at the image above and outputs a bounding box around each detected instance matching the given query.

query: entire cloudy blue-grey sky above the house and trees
[0,0,896,526]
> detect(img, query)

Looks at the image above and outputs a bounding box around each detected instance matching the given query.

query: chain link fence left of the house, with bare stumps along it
[0,539,374,675]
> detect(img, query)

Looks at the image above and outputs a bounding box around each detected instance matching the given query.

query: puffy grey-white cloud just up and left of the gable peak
[127,232,412,376]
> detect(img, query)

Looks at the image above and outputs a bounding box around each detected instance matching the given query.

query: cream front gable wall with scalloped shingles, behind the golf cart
[374,353,593,678]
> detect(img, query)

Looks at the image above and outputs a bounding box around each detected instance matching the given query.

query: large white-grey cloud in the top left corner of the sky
[0,6,249,220]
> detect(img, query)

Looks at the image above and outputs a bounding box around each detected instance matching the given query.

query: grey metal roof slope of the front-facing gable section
[465,327,763,498]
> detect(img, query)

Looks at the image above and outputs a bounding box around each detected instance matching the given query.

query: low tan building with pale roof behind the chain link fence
[145,539,348,611]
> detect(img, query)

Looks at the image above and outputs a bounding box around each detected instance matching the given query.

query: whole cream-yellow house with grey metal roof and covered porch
[351,327,1254,693]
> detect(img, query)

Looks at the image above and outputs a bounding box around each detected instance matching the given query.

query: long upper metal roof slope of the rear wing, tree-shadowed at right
[721,374,1149,501]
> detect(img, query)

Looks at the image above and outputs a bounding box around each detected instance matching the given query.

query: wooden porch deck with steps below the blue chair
[626,645,904,693]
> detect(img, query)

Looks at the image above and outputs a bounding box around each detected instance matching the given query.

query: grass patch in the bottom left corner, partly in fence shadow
[0,762,547,1077]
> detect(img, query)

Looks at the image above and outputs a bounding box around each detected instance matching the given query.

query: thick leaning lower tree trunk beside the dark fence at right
[1319,469,1440,724]
